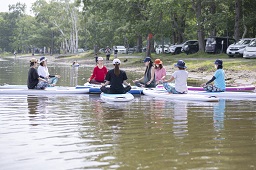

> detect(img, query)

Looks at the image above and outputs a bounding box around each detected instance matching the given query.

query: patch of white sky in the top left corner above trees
[0,0,36,14]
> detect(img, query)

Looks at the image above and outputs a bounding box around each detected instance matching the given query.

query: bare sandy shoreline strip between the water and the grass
[1,55,256,86]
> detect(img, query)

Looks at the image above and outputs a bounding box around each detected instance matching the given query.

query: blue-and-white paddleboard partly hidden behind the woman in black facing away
[76,83,142,94]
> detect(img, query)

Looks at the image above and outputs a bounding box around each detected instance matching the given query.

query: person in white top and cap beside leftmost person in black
[37,57,60,86]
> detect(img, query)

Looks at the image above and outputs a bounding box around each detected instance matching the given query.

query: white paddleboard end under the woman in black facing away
[100,93,134,102]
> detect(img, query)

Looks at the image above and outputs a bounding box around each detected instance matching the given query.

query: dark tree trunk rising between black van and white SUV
[234,0,241,41]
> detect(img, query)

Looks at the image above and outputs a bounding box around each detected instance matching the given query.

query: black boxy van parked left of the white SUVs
[205,37,236,54]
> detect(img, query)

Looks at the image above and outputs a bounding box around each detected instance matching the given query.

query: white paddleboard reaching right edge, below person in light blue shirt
[188,91,256,100]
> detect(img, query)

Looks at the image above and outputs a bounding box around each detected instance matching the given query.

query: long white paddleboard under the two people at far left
[0,87,89,95]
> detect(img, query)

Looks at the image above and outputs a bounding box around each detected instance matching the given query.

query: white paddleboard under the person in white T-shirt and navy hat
[143,89,219,102]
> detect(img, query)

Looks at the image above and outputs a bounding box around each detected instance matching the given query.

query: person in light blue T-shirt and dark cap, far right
[201,59,226,92]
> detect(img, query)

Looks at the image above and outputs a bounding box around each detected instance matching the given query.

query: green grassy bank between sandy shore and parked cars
[75,51,256,72]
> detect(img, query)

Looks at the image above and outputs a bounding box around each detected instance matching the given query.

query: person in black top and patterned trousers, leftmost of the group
[27,58,48,90]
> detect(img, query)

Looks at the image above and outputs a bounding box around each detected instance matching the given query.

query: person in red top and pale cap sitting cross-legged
[87,57,108,84]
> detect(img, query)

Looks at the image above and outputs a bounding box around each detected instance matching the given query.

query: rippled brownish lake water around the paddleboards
[0,57,256,170]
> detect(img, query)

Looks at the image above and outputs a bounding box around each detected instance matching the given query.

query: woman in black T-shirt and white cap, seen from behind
[100,58,131,94]
